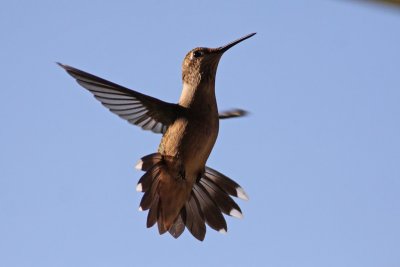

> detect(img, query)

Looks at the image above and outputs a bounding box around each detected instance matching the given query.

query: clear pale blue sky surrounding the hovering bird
[0,0,400,267]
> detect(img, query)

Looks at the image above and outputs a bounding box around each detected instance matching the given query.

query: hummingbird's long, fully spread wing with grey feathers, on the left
[57,63,180,133]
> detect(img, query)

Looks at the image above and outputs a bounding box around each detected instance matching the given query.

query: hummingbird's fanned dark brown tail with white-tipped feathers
[136,153,248,243]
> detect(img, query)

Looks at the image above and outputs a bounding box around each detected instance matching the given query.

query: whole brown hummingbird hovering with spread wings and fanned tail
[57,33,256,241]
